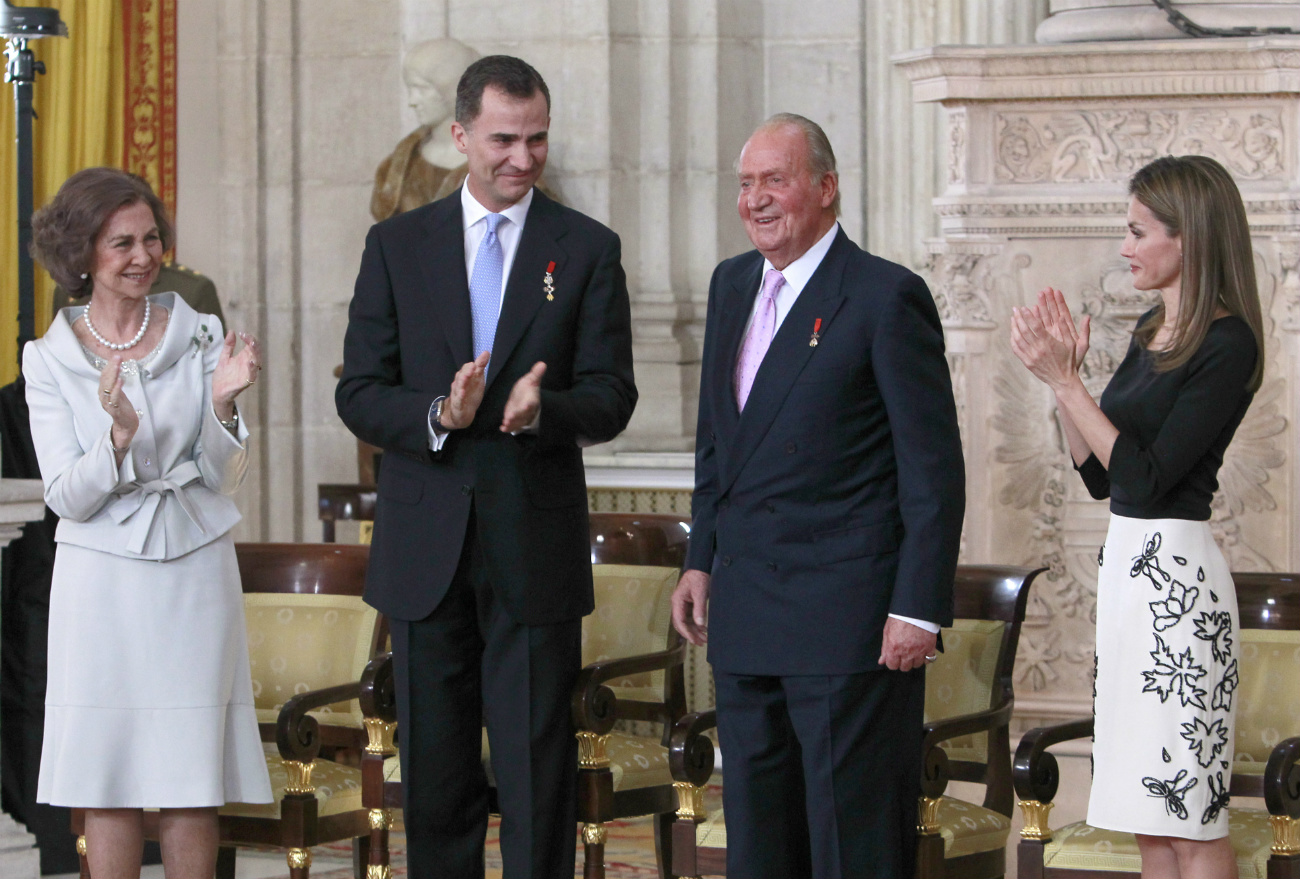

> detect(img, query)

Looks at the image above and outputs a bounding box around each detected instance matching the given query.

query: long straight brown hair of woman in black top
[1128,156,1264,391]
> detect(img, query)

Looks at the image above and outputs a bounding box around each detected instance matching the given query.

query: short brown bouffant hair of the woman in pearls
[31,168,174,298]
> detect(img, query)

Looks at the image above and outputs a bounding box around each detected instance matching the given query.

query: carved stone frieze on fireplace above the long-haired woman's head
[995,105,1290,183]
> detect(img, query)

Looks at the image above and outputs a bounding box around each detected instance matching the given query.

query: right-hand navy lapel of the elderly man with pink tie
[719,229,848,492]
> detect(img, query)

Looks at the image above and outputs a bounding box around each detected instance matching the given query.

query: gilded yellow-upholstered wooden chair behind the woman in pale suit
[73,544,386,879]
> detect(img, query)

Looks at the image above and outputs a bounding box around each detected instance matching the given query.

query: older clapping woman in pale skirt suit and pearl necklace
[22,168,270,879]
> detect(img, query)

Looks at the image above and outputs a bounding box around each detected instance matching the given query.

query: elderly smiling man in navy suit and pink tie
[672,113,965,879]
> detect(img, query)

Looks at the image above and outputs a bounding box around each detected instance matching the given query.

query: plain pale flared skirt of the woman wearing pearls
[36,534,270,809]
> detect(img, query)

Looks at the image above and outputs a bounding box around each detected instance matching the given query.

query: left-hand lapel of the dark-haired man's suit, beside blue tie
[416,196,475,363]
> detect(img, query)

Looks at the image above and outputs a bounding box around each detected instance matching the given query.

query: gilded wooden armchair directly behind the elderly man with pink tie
[670,564,1044,879]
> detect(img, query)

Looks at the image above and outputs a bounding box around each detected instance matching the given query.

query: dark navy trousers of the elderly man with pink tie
[714,670,926,879]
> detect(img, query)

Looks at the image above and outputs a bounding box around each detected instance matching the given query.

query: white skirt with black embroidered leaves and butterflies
[1088,515,1239,840]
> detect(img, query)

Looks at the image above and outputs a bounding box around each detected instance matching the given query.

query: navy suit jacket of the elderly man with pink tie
[688,230,966,675]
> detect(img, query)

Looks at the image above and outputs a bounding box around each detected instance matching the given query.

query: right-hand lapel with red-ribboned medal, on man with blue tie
[488,196,567,387]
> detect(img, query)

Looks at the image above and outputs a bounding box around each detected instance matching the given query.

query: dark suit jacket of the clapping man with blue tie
[335,190,637,625]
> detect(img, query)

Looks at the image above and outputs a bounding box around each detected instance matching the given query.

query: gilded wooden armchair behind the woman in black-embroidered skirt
[1013,572,1300,879]
